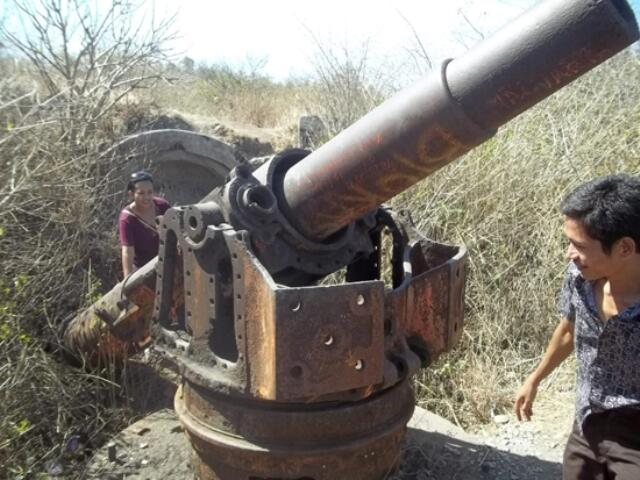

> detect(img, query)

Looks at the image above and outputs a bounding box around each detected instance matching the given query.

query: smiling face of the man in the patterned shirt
[564,217,619,280]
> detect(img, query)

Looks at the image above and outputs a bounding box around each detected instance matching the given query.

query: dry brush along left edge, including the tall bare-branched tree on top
[0,0,175,478]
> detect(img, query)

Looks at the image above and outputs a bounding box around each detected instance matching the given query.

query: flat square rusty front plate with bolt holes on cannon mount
[275,281,384,398]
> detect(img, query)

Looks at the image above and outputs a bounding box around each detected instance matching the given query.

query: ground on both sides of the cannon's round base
[84,391,573,480]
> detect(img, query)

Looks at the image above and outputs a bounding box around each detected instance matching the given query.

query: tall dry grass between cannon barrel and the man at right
[393,52,640,424]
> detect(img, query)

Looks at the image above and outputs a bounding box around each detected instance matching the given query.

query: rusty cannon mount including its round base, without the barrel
[156,198,465,480]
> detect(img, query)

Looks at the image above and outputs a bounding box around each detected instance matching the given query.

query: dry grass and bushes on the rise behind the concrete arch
[144,40,397,144]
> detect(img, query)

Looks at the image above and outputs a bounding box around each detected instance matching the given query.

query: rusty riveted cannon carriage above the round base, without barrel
[155,205,466,402]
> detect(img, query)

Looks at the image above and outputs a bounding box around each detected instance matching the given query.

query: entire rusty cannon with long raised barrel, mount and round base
[62,0,638,480]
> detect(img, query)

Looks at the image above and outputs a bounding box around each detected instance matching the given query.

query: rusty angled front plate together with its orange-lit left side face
[238,242,384,401]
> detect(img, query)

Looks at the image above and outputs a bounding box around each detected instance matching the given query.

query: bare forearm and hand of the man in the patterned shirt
[514,318,574,420]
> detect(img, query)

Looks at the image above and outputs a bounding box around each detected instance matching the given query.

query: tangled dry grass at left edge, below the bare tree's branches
[0,75,148,478]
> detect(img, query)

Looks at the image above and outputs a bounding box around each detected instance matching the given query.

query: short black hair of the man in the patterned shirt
[560,174,640,253]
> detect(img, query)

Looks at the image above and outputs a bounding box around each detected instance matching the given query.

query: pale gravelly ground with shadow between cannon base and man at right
[392,390,574,480]
